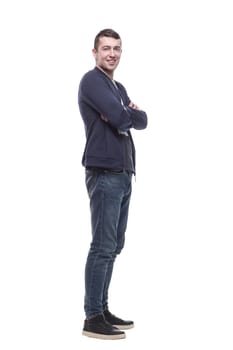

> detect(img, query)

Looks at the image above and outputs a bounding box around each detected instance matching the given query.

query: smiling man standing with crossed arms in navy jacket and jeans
[78,29,147,339]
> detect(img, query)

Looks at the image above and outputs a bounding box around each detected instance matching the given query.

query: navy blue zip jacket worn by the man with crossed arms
[78,67,147,172]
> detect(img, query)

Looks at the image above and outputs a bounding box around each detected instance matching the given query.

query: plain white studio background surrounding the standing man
[0,0,233,350]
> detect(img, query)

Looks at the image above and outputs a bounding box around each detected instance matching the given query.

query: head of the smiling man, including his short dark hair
[92,29,122,78]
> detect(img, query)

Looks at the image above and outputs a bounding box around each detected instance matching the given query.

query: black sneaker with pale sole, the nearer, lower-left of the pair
[82,315,125,339]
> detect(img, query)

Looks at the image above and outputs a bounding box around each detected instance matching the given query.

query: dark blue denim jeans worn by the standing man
[84,170,132,318]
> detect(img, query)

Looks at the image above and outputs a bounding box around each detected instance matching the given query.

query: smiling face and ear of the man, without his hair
[92,36,121,75]
